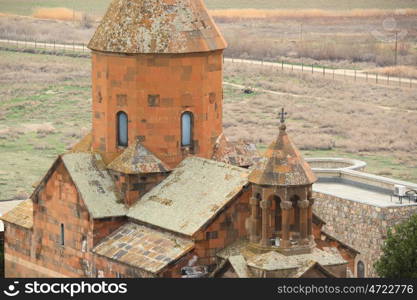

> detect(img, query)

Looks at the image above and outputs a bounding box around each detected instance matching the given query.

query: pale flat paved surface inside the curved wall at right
[313,182,417,207]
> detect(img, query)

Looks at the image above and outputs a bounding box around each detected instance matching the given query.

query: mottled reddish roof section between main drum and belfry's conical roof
[212,134,260,167]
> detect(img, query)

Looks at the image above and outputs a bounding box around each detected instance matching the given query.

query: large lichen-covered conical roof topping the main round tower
[88,0,226,54]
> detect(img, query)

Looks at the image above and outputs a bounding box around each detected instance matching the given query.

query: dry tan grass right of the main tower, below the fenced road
[224,64,417,158]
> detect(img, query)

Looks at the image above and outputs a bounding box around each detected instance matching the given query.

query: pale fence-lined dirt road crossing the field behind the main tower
[0,38,417,88]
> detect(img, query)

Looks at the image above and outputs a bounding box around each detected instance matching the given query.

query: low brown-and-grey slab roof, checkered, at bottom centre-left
[93,223,194,274]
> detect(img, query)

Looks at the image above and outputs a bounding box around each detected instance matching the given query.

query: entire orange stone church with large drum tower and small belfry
[2,0,357,278]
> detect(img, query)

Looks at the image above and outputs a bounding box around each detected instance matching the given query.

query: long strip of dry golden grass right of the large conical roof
[210,8,417,22]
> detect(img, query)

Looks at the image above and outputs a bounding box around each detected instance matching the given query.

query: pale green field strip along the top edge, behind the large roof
[0,0,417,16]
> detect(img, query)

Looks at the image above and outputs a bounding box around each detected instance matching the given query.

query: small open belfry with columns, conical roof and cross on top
[249,109,317,255]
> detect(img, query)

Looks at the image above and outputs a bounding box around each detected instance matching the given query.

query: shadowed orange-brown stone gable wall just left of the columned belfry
[195,188,251,265]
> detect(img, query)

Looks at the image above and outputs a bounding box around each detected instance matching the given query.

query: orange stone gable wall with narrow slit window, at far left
[6,162,93,277]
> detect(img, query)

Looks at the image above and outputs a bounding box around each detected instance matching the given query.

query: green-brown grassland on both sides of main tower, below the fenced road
[0,51,417,200]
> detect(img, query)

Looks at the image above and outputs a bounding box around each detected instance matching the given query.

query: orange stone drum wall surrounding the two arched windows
[92,50,223,167]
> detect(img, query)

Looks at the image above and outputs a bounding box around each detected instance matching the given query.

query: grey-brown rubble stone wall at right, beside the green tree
[313,193,417,277]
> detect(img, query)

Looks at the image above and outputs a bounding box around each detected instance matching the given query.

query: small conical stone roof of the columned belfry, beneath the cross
[249,124,317,186]
